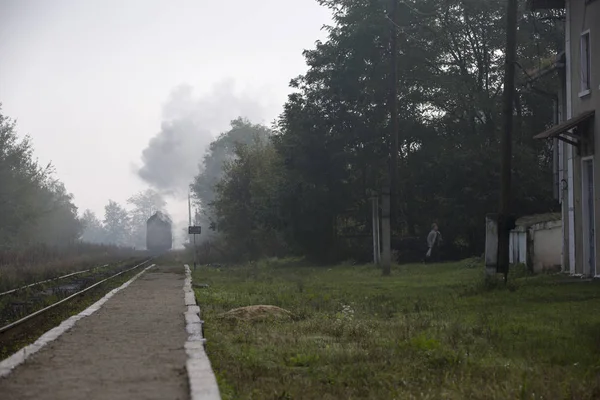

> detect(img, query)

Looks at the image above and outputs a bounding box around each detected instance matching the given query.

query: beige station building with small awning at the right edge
[529,0,600,276]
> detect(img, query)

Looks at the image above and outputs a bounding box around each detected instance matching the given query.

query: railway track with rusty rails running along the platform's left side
[0,257,154,336]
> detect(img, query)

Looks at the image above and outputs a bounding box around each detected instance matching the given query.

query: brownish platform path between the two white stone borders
[0,267,189,400]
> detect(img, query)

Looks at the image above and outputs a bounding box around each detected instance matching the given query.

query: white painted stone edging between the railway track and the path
[0,264,155,378]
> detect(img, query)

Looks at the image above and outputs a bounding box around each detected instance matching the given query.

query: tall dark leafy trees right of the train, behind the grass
[191,0,563,261]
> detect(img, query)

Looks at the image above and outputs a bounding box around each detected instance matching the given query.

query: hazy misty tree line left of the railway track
[0,107,166,254]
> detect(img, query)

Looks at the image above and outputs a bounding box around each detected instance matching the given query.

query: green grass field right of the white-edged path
[194,260,600,399]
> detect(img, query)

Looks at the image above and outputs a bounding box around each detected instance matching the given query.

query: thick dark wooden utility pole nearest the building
[498,0,519,282]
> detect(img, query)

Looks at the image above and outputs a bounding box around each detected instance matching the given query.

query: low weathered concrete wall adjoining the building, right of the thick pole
[529,221,562,272]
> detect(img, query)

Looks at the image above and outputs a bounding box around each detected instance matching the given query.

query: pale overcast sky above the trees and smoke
[0,0,330,223]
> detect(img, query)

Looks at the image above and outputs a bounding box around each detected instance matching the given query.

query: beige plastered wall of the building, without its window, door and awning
[567,0,600,275]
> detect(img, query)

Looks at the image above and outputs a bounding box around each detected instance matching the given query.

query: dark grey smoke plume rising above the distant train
[137,81,264,195]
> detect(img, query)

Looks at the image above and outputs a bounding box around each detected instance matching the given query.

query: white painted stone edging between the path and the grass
[183,264,221,400]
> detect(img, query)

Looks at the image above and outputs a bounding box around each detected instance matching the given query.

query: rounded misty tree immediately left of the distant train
[127,189,167,248]
